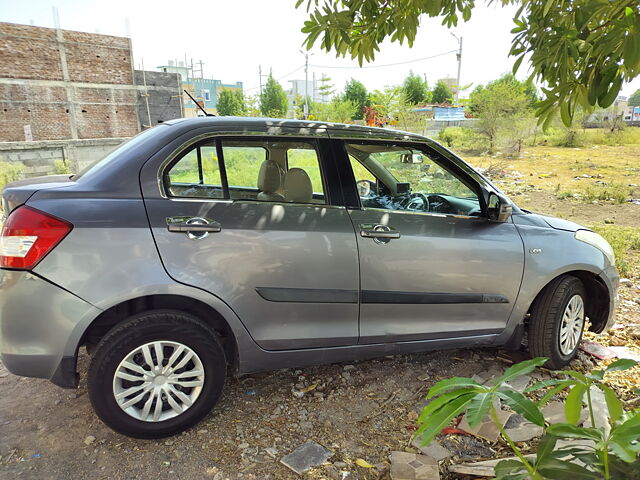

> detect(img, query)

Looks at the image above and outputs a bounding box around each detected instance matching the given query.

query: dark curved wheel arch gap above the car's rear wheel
[78,294,238,371]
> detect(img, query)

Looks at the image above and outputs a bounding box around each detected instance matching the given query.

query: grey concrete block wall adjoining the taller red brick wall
[134,70,183,129]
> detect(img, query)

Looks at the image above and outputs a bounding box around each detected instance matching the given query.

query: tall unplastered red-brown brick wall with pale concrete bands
[0,23,140,142]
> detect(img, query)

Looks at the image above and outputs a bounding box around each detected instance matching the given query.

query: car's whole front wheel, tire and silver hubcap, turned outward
[529,275,586,368]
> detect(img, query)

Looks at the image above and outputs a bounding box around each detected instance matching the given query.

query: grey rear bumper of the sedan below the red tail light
[0,270,97,388]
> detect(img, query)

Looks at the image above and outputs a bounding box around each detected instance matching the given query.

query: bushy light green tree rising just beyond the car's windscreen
[468,76,532,153]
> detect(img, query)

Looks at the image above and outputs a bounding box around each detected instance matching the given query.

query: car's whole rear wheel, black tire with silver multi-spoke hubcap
[88,310,226,438]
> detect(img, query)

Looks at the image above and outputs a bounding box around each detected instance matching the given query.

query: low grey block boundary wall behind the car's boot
[0,138,128,177]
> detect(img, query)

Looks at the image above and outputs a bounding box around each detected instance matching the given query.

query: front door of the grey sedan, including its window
[345,142,524,343]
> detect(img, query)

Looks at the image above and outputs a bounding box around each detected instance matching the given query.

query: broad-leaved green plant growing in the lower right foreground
[416,357,640,480]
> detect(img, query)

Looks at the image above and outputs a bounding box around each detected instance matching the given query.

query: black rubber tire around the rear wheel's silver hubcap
[88,310,226,438]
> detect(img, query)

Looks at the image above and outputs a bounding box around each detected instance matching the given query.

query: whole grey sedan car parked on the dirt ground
[0,117,618,438]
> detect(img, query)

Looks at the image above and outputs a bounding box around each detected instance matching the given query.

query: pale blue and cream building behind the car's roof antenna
[157,60,243,117]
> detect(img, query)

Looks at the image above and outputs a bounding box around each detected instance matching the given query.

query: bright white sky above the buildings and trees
[0,0,640,97]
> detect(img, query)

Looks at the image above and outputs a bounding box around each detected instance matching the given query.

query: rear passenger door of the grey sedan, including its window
[141,135,359,350]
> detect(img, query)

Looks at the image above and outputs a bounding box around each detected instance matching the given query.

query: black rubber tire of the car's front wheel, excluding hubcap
[528,275,587,369]
